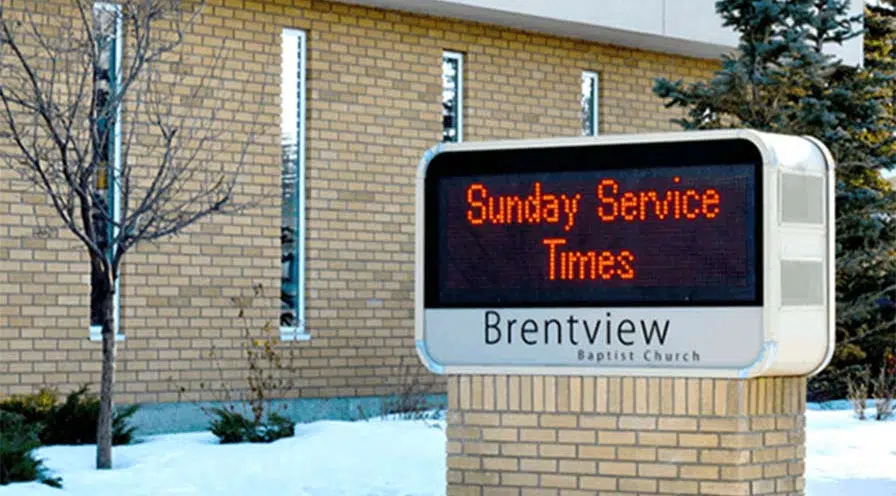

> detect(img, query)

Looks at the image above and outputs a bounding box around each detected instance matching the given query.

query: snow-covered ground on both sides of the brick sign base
[0,410,896,496]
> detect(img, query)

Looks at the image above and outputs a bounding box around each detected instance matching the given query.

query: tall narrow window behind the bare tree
[90,2,124,341]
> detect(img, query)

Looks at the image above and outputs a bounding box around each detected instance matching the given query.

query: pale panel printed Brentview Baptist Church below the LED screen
[426,307,762,370]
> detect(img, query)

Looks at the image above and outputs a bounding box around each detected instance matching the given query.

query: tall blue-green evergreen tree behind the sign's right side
[654,0,896,399]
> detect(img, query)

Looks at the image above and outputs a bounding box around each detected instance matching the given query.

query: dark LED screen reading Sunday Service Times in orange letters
[427,162,760,307]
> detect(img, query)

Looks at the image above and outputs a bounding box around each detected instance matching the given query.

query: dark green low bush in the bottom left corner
[0,410,62,487]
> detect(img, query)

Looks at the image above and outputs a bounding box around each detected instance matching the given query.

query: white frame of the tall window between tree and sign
[280,28,311,341]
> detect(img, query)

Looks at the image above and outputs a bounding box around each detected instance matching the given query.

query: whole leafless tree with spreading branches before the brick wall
[0,0,263,469]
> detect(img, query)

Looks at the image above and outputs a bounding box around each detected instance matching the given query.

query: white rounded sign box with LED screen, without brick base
[417,131,832,376]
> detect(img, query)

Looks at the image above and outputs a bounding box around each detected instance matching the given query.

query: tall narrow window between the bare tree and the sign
[280,29,308,340]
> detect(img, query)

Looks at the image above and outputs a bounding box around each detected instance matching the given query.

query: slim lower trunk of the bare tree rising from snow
[91,261,115,469]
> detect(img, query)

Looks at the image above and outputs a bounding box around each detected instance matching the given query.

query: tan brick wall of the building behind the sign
[0,0,716,402]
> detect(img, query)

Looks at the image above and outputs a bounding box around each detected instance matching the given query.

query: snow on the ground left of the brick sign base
[0,421,445,496]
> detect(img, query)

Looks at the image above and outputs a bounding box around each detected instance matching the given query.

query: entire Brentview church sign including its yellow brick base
[416,130,834,496]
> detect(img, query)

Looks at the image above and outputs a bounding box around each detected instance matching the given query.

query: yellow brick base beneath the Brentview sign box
[447,376,806,496]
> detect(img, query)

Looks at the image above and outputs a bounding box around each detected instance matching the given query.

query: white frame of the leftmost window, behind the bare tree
[89,2,125,341]
